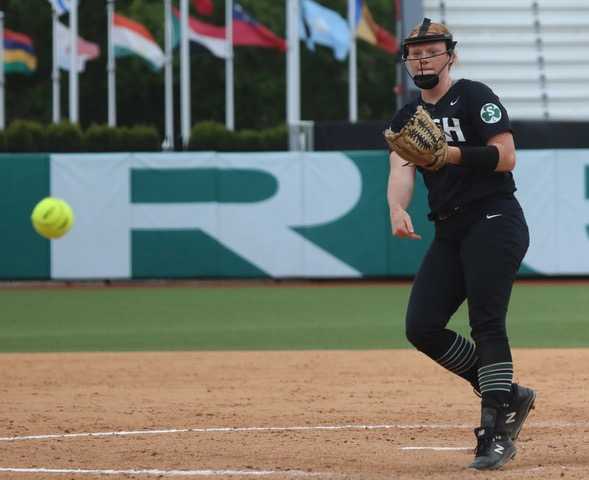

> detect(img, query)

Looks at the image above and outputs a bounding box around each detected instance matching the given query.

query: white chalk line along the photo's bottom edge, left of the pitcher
[0,468,324,477]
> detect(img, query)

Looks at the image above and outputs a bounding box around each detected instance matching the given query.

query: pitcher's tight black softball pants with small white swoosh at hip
[406,196,529,389]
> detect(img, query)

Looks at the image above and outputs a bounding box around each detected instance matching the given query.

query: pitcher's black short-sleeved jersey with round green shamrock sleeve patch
[391,79,515,218]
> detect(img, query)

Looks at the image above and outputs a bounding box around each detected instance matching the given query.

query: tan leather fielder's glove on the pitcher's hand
[383,105,448,171]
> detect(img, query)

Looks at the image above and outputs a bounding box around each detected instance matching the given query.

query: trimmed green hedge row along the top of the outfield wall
[0,120,288,153]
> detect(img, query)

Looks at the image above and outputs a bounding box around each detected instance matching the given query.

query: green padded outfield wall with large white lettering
[0,150,589,279]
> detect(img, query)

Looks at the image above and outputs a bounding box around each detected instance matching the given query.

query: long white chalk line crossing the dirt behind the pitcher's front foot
[0,422,589,442]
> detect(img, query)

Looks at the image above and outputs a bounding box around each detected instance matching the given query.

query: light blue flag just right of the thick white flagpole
[300,0,350,61]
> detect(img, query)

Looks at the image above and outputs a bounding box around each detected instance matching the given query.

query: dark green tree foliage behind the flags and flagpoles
[0,0,395,132]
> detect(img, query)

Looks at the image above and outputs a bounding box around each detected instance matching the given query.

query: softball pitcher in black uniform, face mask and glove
[385,18,536,470]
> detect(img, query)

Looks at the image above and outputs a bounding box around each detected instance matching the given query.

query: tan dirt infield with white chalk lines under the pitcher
[0,350,589,480]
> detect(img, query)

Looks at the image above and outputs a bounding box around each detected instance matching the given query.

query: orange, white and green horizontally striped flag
[112,13,165,70]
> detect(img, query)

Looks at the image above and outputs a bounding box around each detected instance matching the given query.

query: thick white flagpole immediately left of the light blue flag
[286,0,301,150]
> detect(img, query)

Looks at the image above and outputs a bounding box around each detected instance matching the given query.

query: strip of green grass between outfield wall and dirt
[0,284,589,352]
